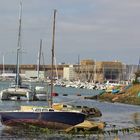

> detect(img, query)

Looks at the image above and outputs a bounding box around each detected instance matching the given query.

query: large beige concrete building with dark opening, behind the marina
[75,60,123,82]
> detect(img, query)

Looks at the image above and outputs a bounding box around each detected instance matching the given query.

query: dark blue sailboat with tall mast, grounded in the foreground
[0,10,86,129]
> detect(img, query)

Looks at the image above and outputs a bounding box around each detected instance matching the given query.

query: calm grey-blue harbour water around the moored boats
[0,82,140,140]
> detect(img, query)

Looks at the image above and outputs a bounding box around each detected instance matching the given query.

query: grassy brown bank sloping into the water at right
[88,84,140,105]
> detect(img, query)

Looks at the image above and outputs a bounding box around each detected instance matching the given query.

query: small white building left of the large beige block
[63,65,77,80]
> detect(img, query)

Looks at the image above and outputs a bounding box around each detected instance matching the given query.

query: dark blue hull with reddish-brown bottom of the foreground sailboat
[0,111,85,129]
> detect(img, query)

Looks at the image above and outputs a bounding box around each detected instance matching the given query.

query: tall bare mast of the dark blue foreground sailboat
[50,10,56,106]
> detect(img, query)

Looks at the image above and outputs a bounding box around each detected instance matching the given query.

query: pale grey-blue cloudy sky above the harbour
[0,0,140,64]
